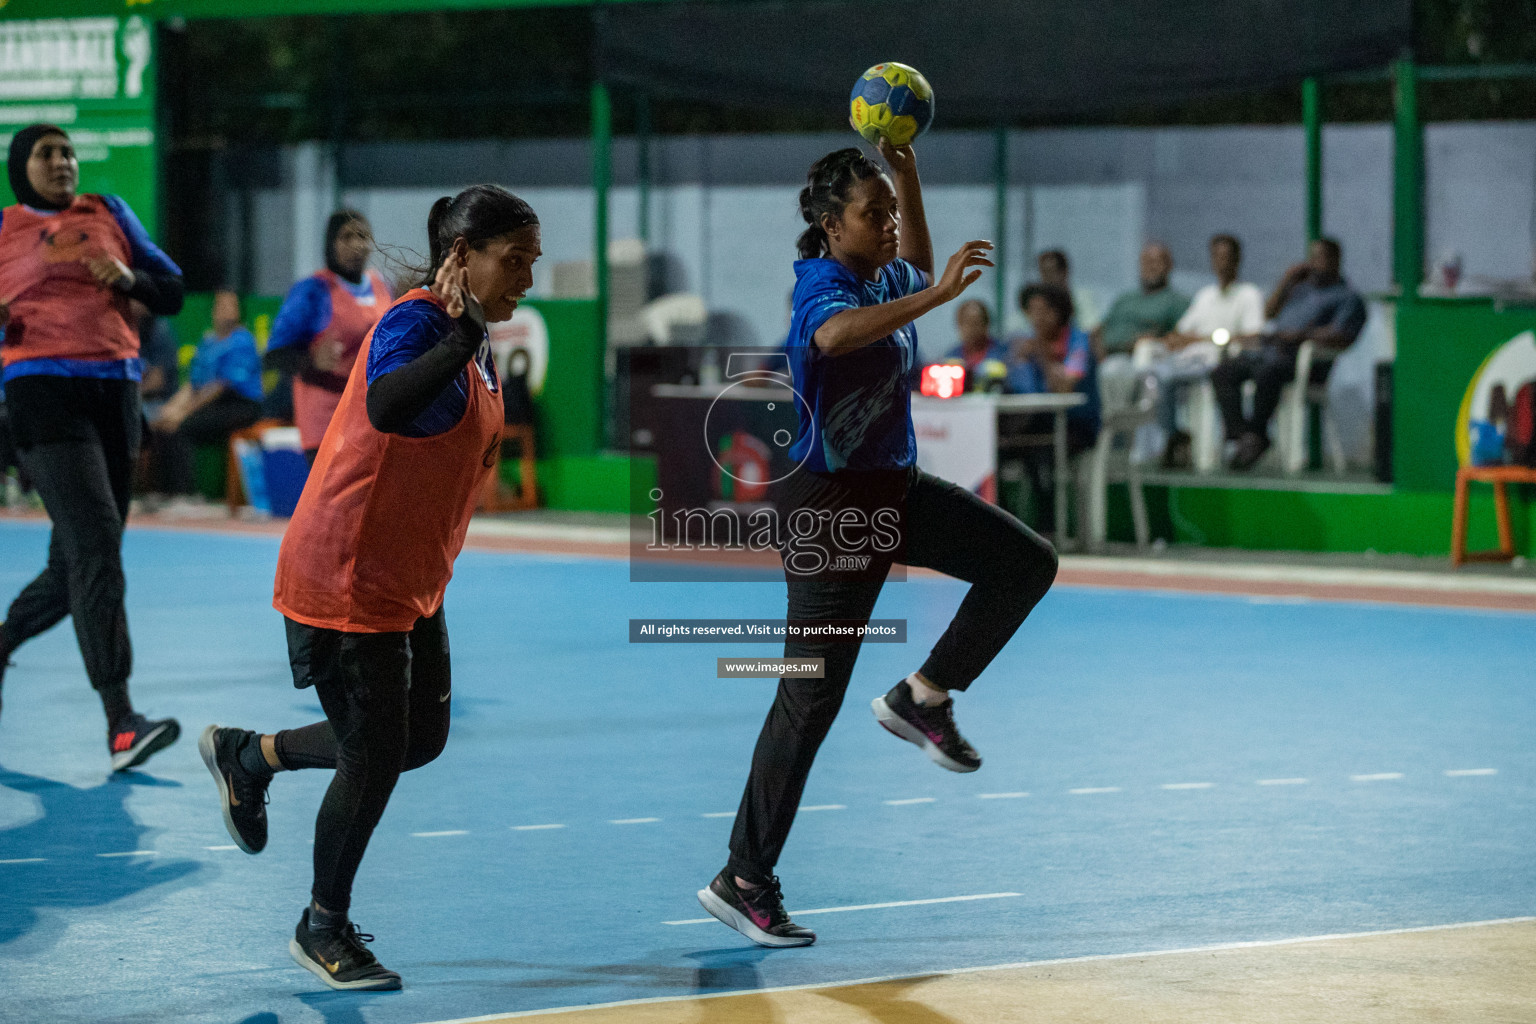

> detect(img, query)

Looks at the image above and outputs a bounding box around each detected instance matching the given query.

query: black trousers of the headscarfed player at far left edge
[0,376,141,728]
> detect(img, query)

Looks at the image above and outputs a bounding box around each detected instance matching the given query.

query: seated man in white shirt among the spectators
[1149,235,1264,468]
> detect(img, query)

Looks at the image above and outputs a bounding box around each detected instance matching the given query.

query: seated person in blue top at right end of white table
[1008,284,1100,533]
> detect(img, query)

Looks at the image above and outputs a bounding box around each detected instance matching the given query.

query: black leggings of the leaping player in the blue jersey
[728,470,1057,883]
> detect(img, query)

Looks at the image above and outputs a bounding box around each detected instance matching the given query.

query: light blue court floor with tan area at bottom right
[0,519,1536,1024]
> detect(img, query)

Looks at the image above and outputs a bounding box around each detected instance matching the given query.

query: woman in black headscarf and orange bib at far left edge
[0,124,183,771]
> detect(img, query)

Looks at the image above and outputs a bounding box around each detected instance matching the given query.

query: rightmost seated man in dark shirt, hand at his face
[1210,238,1366,470]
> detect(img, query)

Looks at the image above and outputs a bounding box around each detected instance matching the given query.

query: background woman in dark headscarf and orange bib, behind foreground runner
[266,210,392,464]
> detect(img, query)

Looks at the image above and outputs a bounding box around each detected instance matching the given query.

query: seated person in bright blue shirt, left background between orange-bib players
[151,292,261,494]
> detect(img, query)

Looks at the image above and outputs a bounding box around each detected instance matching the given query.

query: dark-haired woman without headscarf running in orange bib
[198,186,541,989]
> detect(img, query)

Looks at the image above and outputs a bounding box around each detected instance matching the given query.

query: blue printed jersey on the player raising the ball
[785,259,928,473]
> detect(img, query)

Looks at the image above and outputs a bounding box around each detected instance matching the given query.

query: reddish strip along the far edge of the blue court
[0,513,1536,614]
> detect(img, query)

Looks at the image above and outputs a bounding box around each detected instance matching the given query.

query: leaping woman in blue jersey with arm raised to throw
[699,143,1057,946]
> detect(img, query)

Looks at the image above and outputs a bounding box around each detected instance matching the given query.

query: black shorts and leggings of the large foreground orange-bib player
[273,609,452,913]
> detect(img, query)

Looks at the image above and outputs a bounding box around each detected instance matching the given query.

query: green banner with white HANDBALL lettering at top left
[0,16,157,233]
